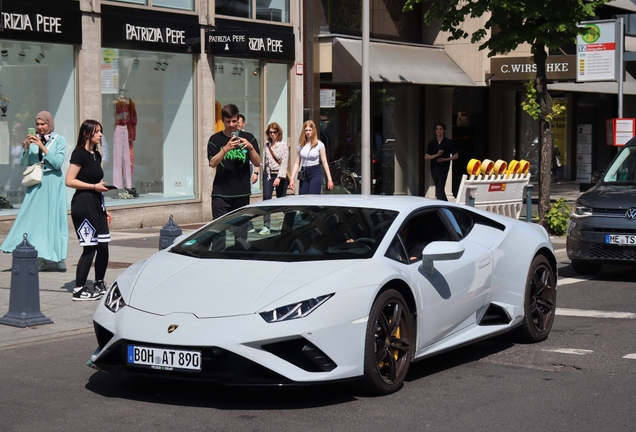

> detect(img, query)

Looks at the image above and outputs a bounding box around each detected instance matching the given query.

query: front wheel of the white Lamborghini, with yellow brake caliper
[360,289,414,395]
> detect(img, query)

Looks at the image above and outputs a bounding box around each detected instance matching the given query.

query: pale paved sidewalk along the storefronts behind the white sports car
[0,182,581,348]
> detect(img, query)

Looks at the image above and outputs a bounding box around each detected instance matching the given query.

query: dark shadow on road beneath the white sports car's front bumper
[85,372,356,410]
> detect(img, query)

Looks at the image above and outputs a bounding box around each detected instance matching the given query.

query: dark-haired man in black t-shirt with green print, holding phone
[208,104,261,219]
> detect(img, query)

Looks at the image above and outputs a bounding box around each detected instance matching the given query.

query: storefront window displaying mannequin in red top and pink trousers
[102,48,196,205]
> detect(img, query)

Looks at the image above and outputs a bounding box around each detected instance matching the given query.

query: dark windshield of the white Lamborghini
[171,205,398,262]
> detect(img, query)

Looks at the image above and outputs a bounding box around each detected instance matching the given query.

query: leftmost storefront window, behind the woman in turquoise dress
[0,40,77,215]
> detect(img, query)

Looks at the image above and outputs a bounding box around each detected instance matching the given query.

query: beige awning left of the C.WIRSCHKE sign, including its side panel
[332,38,477,87]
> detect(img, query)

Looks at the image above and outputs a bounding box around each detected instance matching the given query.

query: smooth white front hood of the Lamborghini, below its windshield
[127,252,357,318]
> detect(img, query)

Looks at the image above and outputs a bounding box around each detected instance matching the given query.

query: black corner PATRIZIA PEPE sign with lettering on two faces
[206,30,295,61]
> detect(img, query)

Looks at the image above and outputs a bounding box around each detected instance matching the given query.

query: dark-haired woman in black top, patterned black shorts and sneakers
[66,120,112,301]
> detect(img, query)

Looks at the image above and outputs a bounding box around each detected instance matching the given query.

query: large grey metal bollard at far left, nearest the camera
[0,233,53,328]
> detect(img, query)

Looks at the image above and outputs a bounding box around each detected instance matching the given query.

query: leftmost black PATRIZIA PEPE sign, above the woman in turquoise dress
[0,0,82,44]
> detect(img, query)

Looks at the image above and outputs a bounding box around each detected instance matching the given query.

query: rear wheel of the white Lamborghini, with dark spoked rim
[518,255,556,343]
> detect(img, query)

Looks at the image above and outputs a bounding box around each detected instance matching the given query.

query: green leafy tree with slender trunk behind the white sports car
[404,0,609,226]
